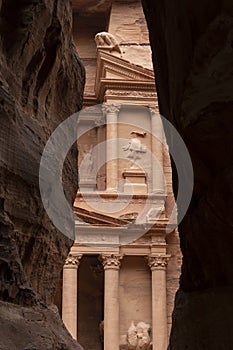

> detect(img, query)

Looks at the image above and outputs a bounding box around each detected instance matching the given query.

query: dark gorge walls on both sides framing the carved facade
[0,0,233,350]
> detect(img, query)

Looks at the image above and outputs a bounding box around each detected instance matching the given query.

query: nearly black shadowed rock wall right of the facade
[143,0,233,350]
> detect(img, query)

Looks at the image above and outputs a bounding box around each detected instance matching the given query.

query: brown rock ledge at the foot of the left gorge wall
[0,302,82,350]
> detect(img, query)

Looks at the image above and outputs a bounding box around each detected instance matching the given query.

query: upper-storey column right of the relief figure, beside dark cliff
[150,109,165,194]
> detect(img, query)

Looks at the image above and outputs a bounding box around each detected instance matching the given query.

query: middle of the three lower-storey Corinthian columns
[101,254,122,350]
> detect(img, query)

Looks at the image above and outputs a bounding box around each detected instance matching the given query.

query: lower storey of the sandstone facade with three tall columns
[57,227,181,350]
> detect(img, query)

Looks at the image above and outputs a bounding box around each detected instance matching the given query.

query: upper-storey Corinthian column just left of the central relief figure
[102,103,120,191]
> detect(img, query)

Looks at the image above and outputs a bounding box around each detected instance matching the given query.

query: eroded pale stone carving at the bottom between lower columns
[127,322,152,350]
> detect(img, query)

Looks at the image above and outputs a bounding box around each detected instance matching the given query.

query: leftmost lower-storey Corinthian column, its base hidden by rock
[62,254,82,339]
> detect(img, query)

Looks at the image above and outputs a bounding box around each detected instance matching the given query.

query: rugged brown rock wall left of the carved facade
[0,0,84,350]
